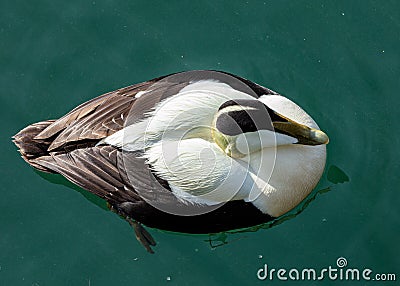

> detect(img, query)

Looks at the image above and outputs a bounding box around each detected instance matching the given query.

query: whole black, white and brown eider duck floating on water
[14,71,328,251]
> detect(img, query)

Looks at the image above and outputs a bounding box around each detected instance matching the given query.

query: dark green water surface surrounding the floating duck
[0,0,400,286]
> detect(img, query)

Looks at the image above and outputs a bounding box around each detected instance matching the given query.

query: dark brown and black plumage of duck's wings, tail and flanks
[14,71,273,236]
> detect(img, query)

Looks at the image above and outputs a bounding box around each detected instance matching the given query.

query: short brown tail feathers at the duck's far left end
[13,120,55,173]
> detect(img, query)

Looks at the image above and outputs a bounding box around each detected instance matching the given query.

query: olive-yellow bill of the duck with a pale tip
[272,119,329,145]
